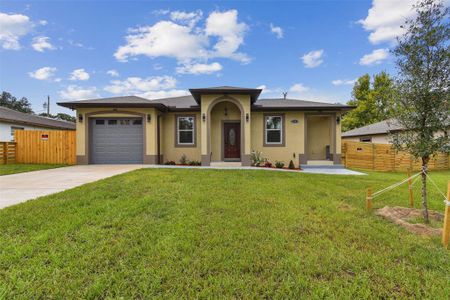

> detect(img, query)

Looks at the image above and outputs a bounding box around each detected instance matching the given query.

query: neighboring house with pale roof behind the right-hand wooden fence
[342,119,450,144]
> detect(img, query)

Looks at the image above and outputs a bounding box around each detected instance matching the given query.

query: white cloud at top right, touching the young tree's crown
[358,0,417,44]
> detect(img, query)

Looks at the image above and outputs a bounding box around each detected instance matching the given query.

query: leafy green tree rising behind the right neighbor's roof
[342,72,395,131]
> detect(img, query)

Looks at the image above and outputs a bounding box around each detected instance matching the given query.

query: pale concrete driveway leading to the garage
[0,165,143,209]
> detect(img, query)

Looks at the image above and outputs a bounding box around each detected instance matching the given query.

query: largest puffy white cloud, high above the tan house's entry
[114,10,250,69]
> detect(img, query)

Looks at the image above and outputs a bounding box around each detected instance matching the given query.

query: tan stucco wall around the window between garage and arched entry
[161,112,201,163]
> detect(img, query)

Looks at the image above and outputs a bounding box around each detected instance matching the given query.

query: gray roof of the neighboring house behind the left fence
[0,106,75,130]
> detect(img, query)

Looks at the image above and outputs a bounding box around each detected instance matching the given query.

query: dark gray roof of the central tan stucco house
[58,91,353,111]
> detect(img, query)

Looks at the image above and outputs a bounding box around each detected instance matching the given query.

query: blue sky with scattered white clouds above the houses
[0,0,418,113]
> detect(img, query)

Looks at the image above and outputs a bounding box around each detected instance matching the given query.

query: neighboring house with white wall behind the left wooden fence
[0,106,75,142]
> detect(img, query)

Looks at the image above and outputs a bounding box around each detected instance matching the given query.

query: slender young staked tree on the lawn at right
[392,0,450,223]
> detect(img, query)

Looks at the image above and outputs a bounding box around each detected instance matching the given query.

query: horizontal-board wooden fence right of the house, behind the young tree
[342,141,450,171]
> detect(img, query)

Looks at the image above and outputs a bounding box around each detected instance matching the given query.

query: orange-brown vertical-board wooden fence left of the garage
[14,130,76,165]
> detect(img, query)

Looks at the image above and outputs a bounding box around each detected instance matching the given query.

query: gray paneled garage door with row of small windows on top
[89,118,144,164]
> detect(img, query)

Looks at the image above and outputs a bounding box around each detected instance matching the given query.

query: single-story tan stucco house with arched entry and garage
[58,86,352,166]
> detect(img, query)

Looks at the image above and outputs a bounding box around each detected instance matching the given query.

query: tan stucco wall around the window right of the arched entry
[251,111,305,166]
